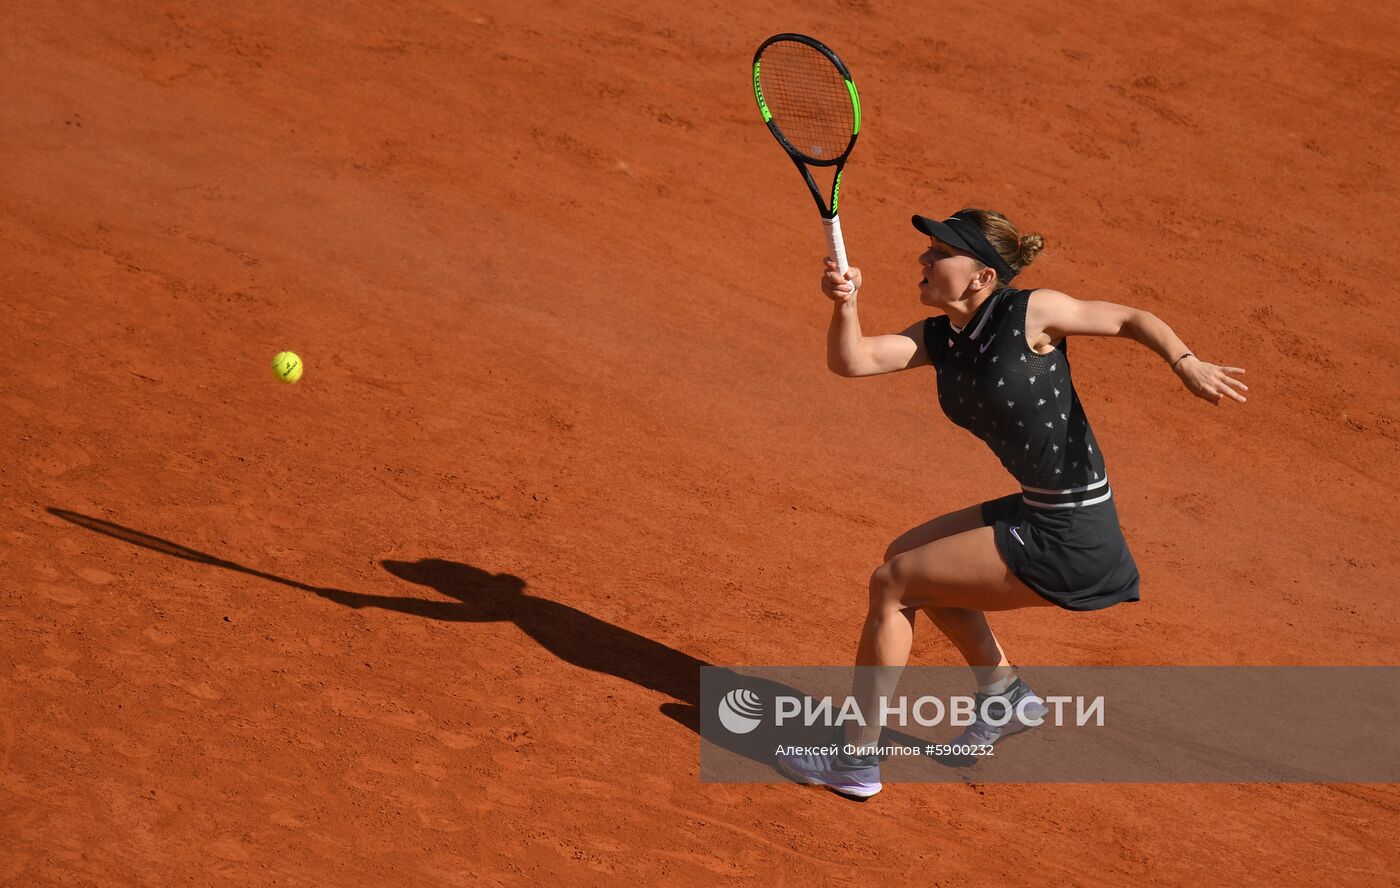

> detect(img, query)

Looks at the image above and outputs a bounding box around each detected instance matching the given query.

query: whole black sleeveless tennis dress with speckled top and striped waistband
[924,289,1138,611]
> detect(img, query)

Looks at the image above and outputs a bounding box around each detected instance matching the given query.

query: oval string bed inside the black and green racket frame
[759,41,855,161]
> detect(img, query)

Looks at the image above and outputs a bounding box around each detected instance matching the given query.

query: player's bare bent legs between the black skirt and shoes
[847,527,1050,745]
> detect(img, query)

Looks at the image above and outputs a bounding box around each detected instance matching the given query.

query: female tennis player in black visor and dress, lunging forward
[780,209,1247,797]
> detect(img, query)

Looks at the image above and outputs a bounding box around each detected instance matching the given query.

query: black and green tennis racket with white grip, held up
[753,34,861,275]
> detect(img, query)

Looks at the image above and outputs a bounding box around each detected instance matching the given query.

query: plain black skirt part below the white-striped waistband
[981,493,1138,611]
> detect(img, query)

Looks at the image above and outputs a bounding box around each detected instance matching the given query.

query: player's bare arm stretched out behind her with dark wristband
[1026,290,1249,406]
